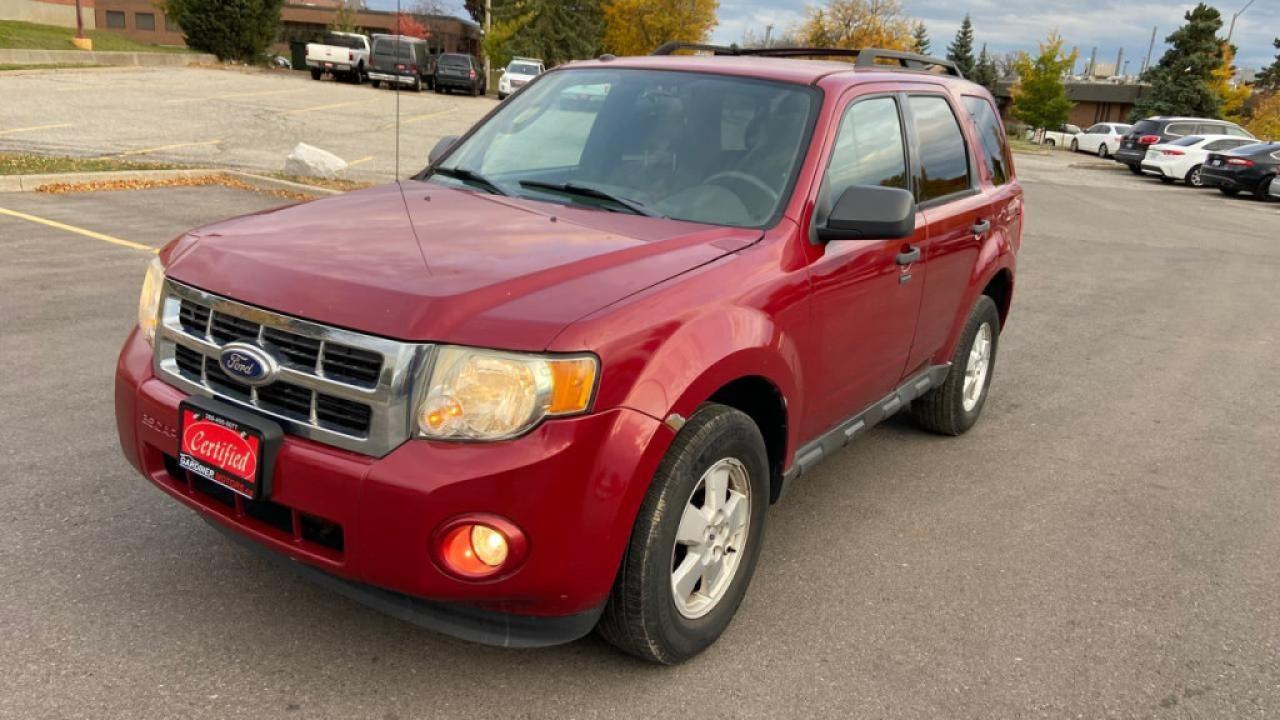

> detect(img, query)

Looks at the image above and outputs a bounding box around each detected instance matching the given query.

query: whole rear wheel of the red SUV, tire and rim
[911,295,1000,436]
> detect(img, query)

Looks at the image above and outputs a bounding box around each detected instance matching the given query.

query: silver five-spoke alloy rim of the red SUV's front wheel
[671,457,751,620]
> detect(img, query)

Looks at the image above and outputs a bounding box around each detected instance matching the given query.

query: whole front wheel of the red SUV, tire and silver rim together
[596,404,769,665]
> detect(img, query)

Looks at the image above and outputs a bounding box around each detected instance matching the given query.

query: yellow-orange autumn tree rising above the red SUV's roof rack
[796,0,915,50]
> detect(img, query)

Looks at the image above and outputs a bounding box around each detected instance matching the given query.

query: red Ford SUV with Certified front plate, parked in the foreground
[115,46,1023,662]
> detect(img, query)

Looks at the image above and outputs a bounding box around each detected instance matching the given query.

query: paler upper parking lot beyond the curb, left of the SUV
[0,68,497,181]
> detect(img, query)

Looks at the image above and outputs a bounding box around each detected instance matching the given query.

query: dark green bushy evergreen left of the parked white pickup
[164,0,284,63]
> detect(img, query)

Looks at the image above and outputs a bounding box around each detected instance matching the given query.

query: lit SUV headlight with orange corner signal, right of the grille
[417,346,599,439]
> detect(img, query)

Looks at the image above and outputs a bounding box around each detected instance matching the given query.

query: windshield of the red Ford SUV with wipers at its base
[431,68,818,227]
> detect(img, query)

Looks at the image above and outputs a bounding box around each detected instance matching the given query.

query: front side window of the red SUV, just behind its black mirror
[820,97,909,210]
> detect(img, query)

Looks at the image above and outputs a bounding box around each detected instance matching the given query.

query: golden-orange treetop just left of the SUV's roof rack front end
[604,0,719,55]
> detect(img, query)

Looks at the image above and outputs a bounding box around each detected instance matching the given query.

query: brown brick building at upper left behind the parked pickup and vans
[87,0,481,55]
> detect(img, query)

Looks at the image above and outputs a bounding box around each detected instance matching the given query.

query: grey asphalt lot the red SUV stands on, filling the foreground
[0,149,1280,720]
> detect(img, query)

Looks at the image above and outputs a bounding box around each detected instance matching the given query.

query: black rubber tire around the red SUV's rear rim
[911,295,1000,436]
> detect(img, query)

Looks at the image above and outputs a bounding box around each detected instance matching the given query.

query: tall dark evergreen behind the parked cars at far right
[1132,3,1222,120]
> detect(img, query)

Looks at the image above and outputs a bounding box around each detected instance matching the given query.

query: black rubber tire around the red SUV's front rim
[596,404,769,665]
